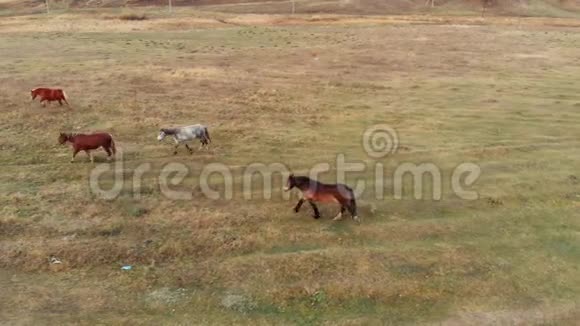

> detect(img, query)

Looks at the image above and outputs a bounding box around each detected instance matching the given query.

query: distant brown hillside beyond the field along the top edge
[0,0,580,17]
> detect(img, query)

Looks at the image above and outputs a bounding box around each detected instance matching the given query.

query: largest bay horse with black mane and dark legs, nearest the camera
[284,174,360,223]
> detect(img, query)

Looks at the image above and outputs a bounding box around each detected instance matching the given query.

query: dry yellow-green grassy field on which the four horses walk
[0,9,580,325]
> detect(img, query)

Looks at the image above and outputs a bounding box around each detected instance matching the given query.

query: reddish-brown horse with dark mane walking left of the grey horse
[58,132,117,163]
